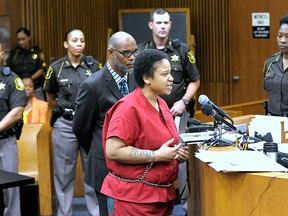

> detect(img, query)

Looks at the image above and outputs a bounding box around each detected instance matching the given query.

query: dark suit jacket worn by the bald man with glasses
[73,65,137,192]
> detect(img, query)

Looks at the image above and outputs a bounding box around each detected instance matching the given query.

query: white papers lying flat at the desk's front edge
[195,150,288,172]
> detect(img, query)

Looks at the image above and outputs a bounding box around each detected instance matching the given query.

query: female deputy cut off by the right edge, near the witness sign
[264,16,288,117]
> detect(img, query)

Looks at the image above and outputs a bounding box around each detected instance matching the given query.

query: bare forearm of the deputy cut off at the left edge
[0,107,24,132]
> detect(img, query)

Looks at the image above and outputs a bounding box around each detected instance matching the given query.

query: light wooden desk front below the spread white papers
[199,161,288,216]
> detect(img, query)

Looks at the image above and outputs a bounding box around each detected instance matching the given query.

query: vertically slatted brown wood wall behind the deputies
[18,0,229,105]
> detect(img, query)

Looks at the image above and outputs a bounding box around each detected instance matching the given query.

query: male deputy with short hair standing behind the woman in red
[138,8,200,214]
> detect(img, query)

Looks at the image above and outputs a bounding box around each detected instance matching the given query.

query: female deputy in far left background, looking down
[5,28,46,100]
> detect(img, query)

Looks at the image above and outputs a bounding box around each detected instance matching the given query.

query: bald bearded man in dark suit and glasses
[73,32,139,216]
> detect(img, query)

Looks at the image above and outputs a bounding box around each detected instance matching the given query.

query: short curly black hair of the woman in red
[133,49,168,88]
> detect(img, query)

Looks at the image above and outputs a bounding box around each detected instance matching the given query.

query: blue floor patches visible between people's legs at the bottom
[53,197,186,216]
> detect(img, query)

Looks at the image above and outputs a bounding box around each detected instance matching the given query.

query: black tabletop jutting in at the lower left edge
[0,170,35,189]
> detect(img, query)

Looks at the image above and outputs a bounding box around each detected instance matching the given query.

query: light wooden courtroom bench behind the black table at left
[17,123,83,215]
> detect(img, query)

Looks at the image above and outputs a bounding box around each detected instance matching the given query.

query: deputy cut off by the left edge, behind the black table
[0,44,27,216]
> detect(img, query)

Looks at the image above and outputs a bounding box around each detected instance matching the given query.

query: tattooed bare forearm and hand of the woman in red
[106,136,180,164]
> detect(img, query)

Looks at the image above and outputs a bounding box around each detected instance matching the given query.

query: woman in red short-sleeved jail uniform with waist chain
[101,49,188,216]
